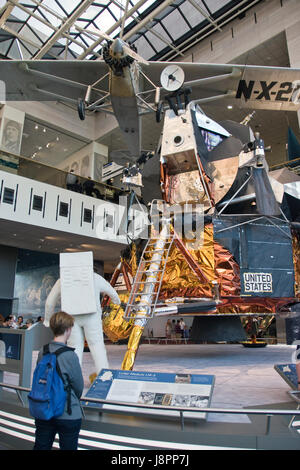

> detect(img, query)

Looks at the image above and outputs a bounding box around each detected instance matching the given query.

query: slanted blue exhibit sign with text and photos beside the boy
[84,369,215,419]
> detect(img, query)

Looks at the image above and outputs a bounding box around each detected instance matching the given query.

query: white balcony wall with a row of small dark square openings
[0,171,127,244]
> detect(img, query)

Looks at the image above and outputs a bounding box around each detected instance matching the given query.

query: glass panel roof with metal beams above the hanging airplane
[0,0,262,60]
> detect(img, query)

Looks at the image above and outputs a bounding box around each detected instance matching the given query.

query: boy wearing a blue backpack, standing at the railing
[28,312,84,450]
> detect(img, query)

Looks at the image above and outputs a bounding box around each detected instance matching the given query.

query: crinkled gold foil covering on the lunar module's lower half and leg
[103,224,300,350]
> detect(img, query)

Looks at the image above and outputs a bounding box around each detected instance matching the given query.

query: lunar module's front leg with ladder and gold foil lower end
[122,219,174,370]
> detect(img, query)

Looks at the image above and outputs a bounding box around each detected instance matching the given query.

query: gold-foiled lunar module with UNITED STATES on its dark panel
[103,91,300,370]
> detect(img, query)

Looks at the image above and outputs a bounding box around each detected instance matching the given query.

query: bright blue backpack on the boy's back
[28,344,74,421]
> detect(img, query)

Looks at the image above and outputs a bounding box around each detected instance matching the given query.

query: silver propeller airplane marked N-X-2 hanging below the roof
[0,26,300,161]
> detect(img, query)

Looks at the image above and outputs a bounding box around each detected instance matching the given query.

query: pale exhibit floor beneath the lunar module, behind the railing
[4,344,295,423]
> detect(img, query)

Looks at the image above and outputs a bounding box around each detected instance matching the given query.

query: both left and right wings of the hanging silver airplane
[0,60,300,111]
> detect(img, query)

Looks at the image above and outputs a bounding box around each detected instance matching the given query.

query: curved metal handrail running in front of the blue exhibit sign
[0,382,300,434]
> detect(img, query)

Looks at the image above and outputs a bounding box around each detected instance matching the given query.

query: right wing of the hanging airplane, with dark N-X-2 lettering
[141,62,300,111]
